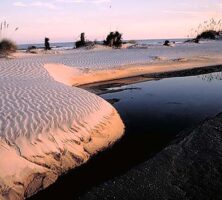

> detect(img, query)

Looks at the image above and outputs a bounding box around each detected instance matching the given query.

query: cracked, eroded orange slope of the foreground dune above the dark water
[0,104,124,199]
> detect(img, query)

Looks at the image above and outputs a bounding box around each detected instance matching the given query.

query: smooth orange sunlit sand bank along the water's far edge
[44,55,222,88]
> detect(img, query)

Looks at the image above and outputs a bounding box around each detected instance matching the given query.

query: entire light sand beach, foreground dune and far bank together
[0,41,222,199]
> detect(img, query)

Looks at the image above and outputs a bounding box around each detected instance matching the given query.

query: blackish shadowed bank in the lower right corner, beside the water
[78,113,222,200]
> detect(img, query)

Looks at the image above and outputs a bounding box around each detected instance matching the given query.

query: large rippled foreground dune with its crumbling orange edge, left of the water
[0,54,124,200]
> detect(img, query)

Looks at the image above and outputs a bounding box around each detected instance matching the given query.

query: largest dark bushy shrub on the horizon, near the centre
[104,31,123,48]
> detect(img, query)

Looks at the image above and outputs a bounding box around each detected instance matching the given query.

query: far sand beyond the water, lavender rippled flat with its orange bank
[16,41,222,85]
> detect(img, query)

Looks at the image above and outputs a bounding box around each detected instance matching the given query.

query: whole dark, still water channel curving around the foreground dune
[29,72,222,199]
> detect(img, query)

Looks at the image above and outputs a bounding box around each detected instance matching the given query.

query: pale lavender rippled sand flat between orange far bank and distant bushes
[15,41,222,70]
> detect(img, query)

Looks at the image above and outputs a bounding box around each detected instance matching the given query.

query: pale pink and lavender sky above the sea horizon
[0,0,222,44]
